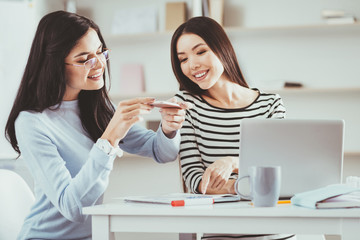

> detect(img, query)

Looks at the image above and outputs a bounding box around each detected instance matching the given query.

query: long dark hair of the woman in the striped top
[170,17,249,95]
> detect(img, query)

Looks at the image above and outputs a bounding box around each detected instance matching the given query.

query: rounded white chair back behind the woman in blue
[0,169,35,240]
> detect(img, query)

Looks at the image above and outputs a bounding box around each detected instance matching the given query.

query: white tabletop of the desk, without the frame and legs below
[83,200,360,218]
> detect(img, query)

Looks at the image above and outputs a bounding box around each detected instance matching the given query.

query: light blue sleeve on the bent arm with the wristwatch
[15,112,115,222]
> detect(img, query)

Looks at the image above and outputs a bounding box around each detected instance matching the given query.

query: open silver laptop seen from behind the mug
[239,119,344,198]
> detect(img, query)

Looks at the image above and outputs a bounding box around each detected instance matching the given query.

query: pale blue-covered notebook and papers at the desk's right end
[291,184,360,209]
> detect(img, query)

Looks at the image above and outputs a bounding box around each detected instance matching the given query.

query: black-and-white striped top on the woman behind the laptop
[175,89,285,193]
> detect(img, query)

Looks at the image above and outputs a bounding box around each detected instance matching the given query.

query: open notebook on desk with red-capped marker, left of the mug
[123,193,240,207]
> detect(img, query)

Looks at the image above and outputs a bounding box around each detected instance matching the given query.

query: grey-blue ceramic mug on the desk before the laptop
[235,166,281,207]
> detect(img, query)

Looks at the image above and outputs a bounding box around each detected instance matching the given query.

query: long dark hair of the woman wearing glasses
[5,11,114,156]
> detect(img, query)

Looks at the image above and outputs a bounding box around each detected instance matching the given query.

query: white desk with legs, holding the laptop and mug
[83,200,360,240]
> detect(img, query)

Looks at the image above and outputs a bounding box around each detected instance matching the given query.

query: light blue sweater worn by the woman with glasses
[15,100,180,240]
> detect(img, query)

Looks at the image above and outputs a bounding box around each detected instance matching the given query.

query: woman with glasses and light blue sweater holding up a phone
[6,11,188,239]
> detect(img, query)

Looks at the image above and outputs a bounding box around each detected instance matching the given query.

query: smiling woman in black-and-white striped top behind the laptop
[171,17,295,240]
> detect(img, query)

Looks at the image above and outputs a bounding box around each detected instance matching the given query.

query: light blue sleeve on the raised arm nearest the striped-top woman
[119,124,180,163]
